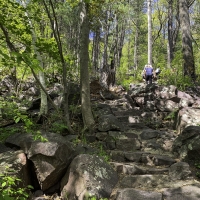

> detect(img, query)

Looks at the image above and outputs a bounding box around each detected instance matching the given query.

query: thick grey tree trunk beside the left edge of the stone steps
[80,2,95,129]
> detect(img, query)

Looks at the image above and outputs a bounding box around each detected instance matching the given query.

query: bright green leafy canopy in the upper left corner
[0,0,60,83]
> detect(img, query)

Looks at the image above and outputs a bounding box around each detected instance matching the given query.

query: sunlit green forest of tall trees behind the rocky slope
[0,0,200,131]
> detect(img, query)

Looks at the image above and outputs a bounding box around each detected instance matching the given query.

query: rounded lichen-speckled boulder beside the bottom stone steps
[61,154,118,200]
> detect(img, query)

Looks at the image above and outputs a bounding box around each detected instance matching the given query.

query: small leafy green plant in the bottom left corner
[0,167,33,200]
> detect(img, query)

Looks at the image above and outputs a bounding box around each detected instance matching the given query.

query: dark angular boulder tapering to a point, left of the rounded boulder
[6,133,74,191]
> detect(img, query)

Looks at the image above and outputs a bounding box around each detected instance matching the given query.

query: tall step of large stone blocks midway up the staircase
[99,128,175,153]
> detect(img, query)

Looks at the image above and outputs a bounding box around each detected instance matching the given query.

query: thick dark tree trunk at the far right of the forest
[179,0,195,80]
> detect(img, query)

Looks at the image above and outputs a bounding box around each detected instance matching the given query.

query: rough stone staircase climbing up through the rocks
[90,82,200,200]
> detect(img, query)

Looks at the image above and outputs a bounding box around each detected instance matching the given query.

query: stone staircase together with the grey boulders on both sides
[0,79,200,200]
